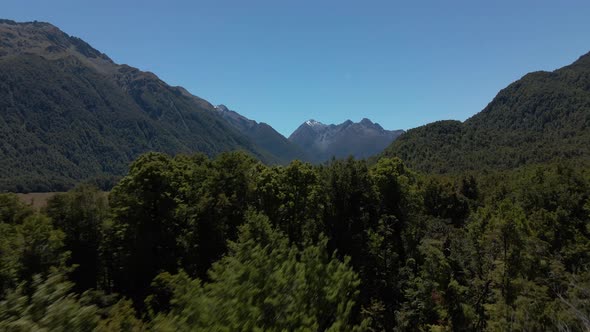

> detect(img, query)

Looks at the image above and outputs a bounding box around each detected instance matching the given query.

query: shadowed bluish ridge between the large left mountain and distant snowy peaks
[215,105,309,164]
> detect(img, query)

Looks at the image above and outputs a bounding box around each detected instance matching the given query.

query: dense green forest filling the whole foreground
[0,152,590,331]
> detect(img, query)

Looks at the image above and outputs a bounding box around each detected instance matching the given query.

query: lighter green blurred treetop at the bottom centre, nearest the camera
[156,214,370,331]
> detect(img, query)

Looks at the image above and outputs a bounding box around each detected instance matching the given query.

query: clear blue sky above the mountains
[0,0,590,136]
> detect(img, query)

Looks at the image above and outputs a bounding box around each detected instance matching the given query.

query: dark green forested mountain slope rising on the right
[383,53,590,173]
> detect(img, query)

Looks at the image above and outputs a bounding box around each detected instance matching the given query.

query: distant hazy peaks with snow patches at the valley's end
[289,119,403,162]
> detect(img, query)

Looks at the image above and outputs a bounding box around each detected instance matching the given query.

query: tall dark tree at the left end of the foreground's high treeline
[104,153,183,301]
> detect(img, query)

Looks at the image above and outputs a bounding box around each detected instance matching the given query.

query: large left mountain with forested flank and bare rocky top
[0,20,279,191]
